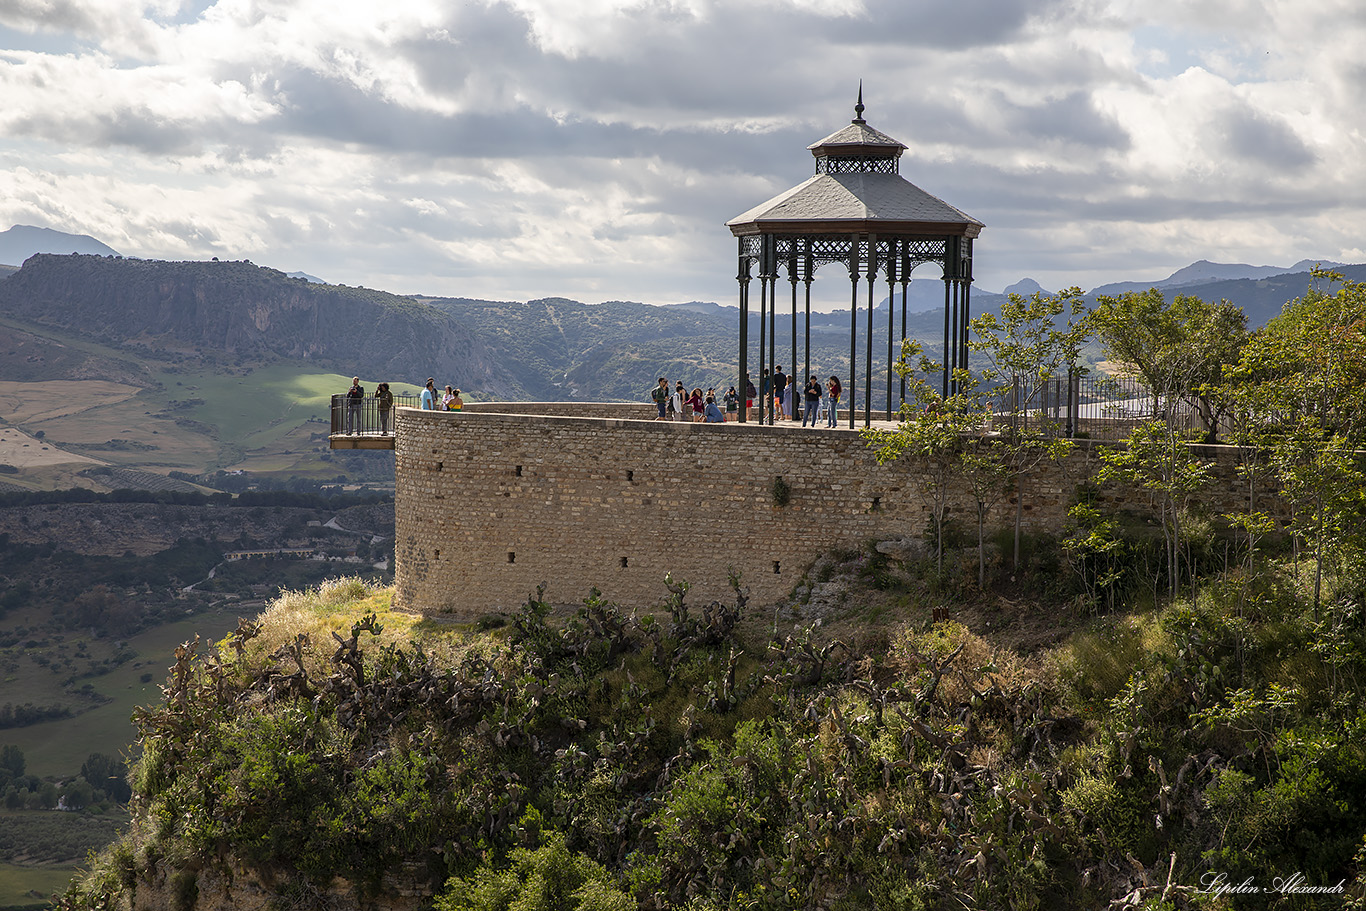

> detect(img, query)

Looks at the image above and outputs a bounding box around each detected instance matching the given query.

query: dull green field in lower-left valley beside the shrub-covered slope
[0,604,245,777]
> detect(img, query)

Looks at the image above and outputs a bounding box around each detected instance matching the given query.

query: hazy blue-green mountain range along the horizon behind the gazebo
[0,225,1366,400]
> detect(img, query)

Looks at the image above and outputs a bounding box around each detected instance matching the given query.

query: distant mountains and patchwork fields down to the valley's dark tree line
[0,254,1366,490]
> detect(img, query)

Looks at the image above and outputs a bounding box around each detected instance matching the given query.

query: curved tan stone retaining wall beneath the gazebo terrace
[395,408,1273,619]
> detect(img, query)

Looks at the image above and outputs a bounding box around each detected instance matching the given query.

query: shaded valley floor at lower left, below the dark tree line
[0,492,393,908]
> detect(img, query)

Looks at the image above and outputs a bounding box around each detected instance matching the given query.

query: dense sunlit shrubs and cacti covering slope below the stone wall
[42,549,1366,908]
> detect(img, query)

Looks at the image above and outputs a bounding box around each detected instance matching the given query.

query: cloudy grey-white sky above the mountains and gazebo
[0,0,1366,309]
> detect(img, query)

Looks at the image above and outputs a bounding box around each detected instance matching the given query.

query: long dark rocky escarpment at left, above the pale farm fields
[0,254,522,396]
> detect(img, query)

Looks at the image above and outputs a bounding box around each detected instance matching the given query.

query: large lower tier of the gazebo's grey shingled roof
[725,172,985,238]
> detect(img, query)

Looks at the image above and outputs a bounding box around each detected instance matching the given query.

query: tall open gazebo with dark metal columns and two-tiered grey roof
[725,85,985,429]
